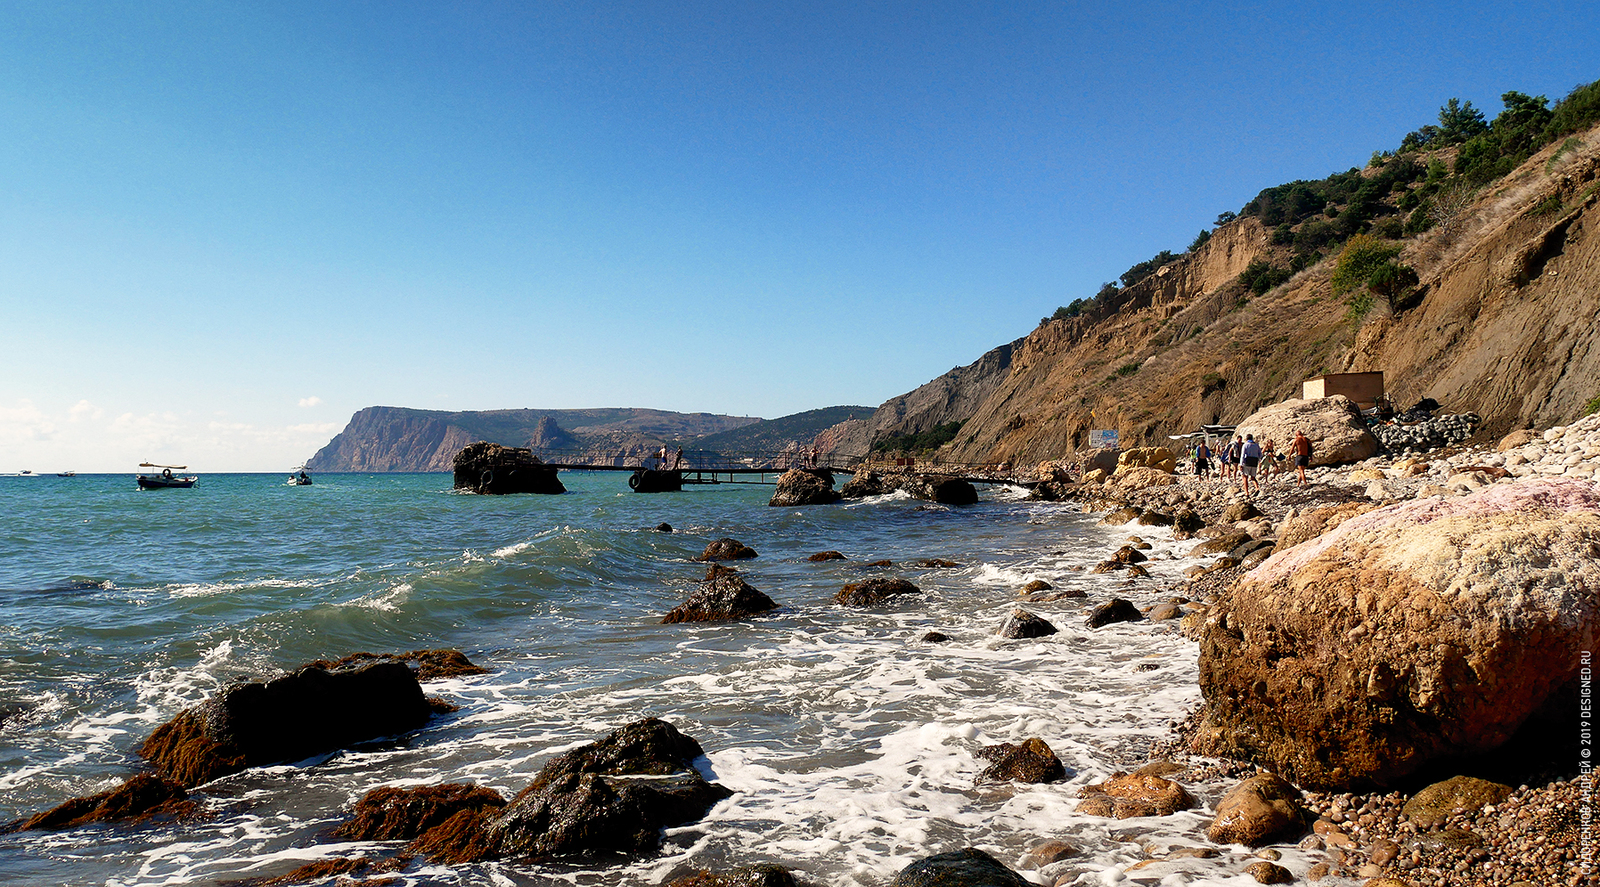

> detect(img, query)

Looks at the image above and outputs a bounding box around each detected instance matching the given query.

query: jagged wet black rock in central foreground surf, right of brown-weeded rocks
[483,717,733,858]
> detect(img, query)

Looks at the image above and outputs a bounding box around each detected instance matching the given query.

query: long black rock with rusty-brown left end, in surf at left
[139,661,434,786]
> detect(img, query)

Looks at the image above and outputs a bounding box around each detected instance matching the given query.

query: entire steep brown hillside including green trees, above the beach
[872,82,1600,463]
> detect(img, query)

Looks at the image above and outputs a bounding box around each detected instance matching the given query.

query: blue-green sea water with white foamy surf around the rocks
[0,472,1280,885]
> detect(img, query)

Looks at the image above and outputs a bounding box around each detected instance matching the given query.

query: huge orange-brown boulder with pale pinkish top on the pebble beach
[1195,479,1600,789]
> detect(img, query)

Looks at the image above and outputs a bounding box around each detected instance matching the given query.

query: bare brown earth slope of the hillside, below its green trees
[872,128,1600,464]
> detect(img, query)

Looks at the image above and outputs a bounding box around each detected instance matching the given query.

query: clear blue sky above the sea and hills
[9,2,1600,471]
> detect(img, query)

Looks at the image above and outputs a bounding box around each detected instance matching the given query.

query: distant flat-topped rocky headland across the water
[306,407,760,471]
